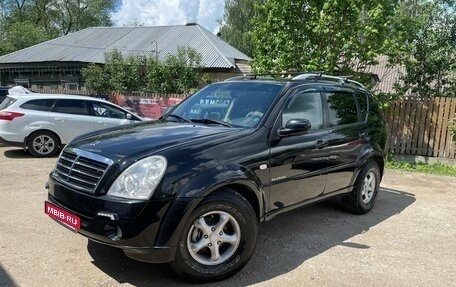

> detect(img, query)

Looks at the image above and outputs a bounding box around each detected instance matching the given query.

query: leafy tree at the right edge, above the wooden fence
[390,0,456,97]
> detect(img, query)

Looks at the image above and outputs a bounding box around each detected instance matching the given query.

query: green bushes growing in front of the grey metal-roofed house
[82,47,201,93]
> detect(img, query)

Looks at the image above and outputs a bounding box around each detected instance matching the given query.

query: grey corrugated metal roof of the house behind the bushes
[0,25,251,68]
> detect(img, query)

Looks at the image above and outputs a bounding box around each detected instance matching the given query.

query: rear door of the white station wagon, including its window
[49,99,94,143]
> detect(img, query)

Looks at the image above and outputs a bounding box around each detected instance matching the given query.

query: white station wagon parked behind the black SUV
[0,93,146,157]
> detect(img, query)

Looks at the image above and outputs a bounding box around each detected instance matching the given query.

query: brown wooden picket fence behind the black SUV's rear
[385,97,456,159]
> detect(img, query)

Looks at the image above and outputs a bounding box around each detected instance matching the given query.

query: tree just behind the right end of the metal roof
[219,0,264,57]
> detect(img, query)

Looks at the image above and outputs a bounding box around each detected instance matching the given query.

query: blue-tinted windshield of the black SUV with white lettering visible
[169,82,282,128]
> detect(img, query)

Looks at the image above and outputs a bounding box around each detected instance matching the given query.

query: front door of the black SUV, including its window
[269,88,329,211]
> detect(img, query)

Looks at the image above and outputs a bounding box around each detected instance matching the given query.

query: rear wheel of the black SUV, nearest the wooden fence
[342,161,381,214]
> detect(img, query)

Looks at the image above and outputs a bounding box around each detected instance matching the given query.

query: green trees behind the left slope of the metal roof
[0,0,116,55]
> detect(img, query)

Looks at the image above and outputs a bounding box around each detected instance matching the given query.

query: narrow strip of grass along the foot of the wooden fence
[386,161,456,176]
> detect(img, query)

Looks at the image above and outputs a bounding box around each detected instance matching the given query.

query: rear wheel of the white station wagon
[27,131,60,157]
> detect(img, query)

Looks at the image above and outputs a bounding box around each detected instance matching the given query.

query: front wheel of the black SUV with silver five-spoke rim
[171,190,258,282]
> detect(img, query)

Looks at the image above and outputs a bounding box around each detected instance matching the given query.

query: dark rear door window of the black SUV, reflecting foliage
[327,91,359,127]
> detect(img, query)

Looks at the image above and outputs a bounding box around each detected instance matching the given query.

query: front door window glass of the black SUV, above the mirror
[282,90,323,130]
